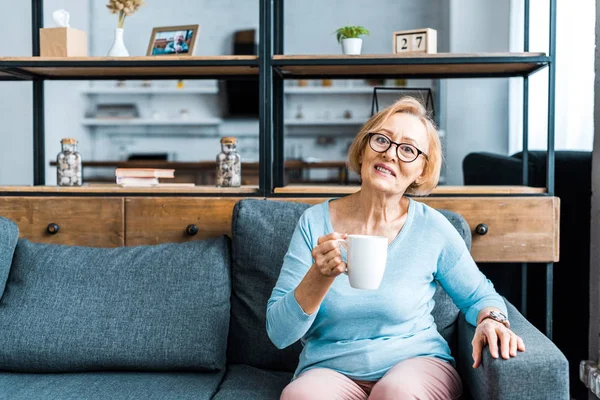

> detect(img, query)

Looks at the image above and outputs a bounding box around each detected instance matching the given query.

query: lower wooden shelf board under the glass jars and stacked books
[0,183,258,195]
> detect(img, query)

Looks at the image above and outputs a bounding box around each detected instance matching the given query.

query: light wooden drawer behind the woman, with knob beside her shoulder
[274,197,560,262]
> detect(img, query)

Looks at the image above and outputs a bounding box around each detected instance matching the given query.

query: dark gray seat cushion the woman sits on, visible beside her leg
[214,365,292,400]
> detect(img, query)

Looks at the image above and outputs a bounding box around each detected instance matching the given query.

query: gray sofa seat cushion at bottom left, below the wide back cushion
[0,371,225,400]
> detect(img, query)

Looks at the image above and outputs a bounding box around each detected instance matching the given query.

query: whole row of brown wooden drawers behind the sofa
[0,196,560,263]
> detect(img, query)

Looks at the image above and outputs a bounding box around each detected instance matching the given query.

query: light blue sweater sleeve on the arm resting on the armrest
[435,228,507,326]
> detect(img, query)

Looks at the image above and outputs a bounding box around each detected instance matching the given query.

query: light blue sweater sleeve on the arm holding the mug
[267,215,318,349]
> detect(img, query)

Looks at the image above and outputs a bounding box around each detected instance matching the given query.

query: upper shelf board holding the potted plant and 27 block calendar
[273,53,549,78]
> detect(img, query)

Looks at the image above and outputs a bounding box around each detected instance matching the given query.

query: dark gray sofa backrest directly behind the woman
[227,199,471,372]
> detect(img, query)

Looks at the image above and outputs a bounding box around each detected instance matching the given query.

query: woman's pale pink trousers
[281,357,462,400]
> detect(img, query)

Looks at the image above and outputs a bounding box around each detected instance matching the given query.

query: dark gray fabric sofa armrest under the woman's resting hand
[457,300,569,400]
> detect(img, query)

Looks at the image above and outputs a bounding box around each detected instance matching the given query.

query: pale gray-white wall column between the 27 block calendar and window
[445,0,509,185]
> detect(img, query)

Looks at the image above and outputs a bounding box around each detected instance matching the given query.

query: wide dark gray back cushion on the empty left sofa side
[0,236,231,372]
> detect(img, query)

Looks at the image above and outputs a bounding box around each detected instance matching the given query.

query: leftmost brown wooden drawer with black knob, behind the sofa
[0,197,125,247]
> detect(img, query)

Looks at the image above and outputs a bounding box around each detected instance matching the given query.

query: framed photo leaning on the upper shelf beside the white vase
[146,25,199,56]
